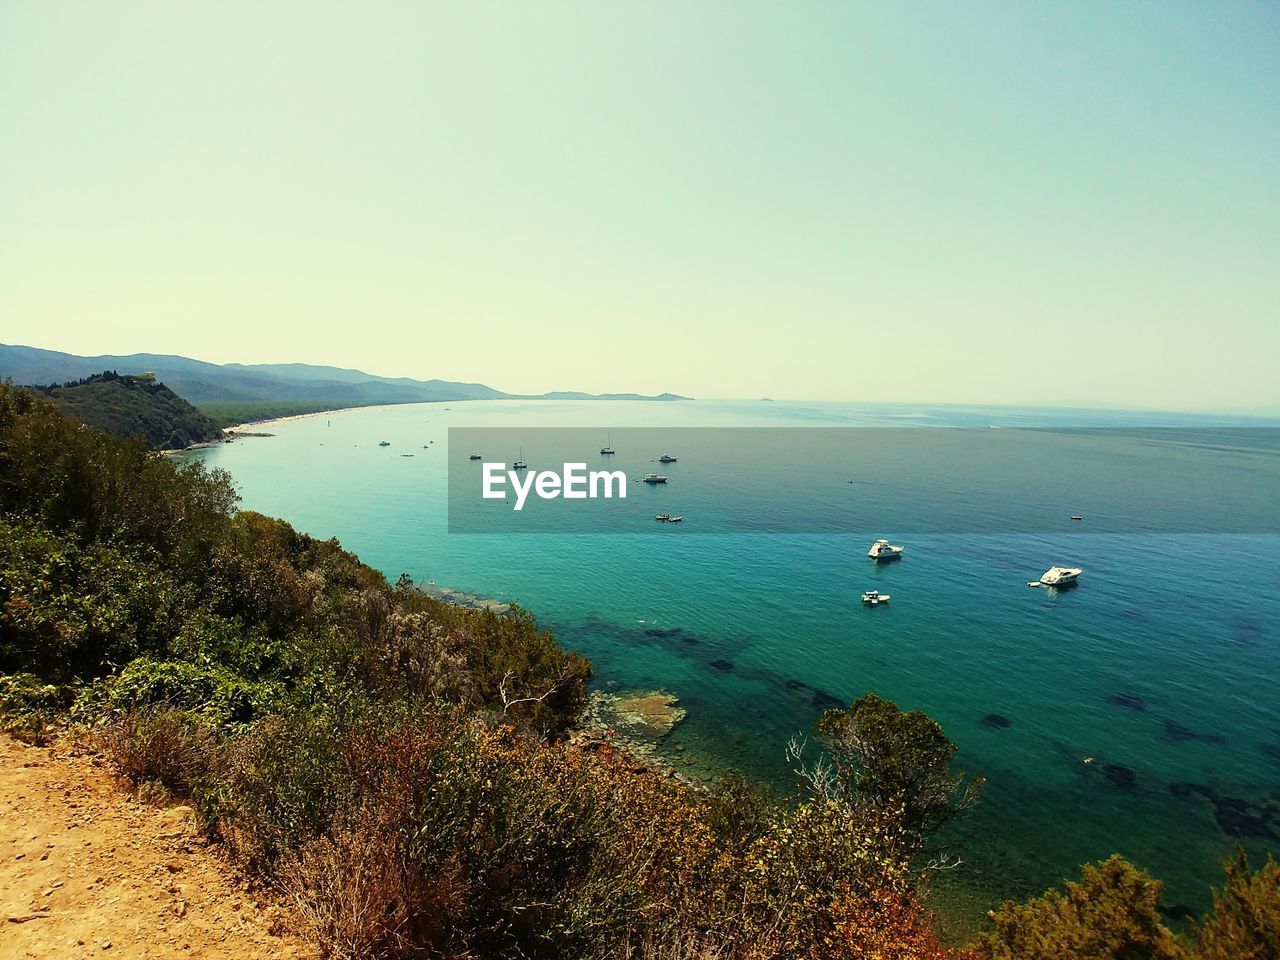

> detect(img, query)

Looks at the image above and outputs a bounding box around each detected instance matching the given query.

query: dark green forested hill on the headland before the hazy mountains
[35,370,221,451]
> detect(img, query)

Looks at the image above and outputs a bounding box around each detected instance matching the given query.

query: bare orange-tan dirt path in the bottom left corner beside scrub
[0,736,314,960]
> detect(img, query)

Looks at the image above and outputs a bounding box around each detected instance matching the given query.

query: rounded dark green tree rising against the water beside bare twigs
[792,694,983,855]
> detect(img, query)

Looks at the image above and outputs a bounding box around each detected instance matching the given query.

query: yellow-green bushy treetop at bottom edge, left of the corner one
[974,854,1182,960]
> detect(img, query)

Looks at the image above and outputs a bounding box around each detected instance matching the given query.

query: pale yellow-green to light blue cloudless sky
[0,0,1280,410]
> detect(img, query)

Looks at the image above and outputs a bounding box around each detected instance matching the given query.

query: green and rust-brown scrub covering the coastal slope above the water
[0,385,1280,960]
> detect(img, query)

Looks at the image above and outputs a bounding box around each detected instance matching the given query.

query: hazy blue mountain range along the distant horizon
[0,344,689,422]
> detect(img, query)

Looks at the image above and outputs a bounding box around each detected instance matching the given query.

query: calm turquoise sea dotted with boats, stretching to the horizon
[186,401,1280,936]
